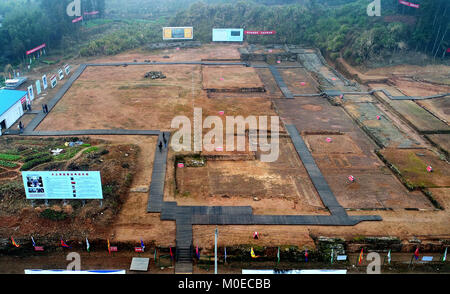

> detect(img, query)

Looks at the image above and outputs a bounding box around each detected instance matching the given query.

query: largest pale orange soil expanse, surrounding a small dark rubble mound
[38,65,274,130]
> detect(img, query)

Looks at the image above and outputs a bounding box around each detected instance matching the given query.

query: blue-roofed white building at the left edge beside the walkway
[0,89,28,131]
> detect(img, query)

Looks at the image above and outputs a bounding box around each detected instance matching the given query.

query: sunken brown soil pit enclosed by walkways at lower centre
[175,139,327,214]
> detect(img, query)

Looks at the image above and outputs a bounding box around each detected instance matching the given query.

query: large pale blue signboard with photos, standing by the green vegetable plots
[22,171,103,200]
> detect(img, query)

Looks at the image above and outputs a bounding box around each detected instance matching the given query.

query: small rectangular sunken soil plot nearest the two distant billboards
[202,66,264,92]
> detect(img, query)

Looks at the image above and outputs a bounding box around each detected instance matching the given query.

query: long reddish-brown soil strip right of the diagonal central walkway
[275,97,432,209]
